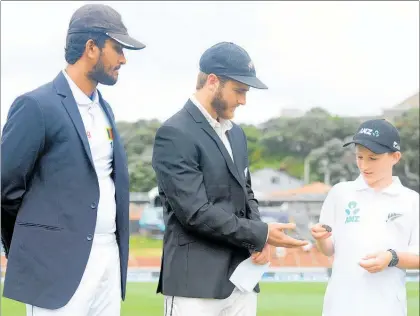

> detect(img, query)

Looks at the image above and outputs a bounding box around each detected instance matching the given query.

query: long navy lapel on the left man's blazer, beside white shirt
[54,72,94,167]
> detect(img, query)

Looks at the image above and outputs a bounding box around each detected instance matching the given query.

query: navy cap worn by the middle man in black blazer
[200,42,268,89]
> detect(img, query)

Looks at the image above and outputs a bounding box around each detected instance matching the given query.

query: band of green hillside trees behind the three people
[117,108,419,191]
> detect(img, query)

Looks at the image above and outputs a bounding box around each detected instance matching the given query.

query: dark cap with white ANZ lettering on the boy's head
[343,119,401,154]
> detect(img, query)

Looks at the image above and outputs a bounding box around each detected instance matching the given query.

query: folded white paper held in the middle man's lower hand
[229,258,270,292]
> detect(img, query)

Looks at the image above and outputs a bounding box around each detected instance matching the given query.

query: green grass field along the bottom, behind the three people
[1,283,419,316]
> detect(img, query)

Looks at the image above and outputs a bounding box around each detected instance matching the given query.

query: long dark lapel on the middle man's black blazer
[185,100,244,187]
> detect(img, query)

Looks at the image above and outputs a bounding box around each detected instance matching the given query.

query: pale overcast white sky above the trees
[1,1,419,125]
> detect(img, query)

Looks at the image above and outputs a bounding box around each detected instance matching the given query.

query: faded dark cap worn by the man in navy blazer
[67,4,146,50]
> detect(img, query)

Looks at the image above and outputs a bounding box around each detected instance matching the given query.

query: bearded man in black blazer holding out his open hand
[153,42,306,316]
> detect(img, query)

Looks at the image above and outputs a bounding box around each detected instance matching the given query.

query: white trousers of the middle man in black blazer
[164,288,257,316]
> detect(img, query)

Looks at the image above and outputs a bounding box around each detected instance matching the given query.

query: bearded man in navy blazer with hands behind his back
[1,4,145,316]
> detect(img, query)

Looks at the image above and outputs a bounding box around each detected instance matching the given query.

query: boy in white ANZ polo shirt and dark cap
[312,119,420,316]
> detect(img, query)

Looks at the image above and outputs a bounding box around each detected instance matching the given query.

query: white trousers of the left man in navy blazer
[26,234,121,316]
